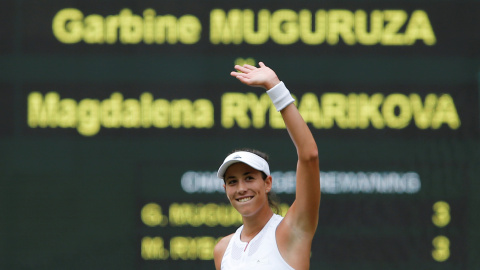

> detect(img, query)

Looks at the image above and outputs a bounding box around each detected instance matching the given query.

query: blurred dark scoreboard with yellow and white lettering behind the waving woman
[0,0,480,269]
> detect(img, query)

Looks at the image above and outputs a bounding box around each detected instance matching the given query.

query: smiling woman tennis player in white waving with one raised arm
[214,62,320,270]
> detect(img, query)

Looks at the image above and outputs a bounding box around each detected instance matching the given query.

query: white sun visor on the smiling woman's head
[217,151,270,179]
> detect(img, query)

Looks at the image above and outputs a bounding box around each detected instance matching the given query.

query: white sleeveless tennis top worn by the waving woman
[221,214,294,270]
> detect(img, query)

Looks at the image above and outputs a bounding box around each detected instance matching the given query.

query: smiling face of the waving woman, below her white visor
[224,162,272,217]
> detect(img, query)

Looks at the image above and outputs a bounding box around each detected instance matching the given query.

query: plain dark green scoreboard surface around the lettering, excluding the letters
[0,0,480,269]
